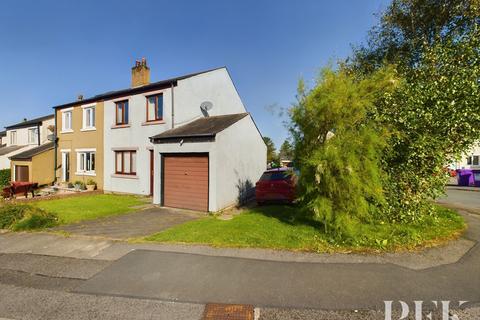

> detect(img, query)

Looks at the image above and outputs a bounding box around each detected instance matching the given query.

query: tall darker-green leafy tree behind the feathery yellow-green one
[347,0,480,222]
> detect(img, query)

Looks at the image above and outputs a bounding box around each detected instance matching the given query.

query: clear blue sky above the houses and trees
[0,0,388,148]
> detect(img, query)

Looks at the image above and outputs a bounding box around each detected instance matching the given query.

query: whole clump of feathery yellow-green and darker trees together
[291,0,480,238]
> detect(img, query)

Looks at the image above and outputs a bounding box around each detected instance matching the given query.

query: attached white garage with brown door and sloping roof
[150,113,267,212]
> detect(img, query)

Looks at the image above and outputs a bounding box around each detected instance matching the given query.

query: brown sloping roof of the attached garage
[150,113,248,142]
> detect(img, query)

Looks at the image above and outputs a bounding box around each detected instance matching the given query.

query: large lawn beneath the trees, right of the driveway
[144,206,464,252]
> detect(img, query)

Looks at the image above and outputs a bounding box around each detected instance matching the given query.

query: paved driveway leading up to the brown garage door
[51,208,205,240]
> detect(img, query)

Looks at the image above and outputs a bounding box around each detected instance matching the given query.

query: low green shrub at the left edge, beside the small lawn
[0,204,57,231]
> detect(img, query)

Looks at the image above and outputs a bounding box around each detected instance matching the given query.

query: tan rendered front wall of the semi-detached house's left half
[55,102,104,189]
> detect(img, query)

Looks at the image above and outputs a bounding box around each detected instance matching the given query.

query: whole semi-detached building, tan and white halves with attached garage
[54,60,266,211]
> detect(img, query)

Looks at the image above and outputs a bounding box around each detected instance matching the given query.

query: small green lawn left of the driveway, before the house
[33,194,145,224]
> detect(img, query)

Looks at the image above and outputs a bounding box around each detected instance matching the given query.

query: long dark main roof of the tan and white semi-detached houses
[53,67,225,109]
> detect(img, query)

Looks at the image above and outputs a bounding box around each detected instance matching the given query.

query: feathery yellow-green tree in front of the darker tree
[291,68,395,237]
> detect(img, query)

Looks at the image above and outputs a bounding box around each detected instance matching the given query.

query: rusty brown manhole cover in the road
[203,303,253,320]
